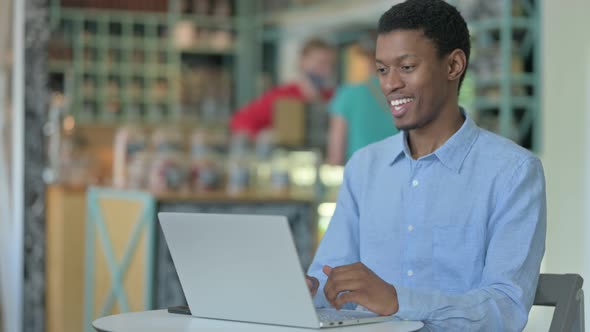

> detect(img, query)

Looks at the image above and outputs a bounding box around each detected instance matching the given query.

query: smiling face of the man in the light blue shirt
[375,30,457,130]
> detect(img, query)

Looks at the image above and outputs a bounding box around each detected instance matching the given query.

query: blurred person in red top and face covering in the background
[230,39,335,137]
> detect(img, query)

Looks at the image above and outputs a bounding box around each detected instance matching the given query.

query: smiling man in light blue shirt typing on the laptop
[308,0,546,331]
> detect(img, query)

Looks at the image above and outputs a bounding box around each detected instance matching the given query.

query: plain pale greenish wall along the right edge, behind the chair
[527,0,590,331]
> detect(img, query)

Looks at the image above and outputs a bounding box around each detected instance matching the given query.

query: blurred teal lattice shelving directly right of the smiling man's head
[454,0,541,151]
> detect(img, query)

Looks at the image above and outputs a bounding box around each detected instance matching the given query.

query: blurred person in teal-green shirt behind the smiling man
[327,33,398,165]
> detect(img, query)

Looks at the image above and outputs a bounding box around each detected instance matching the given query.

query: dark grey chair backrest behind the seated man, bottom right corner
[533,273,584,332]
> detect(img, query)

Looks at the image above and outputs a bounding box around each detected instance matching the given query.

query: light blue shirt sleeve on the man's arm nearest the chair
[394,158,546,331]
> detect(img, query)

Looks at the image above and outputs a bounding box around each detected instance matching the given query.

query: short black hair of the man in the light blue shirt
[377,0,471,90]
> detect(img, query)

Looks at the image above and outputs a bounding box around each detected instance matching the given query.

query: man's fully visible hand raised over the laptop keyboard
[323,262,399,316]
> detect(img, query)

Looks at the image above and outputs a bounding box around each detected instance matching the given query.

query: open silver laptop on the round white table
[158,212,423,331]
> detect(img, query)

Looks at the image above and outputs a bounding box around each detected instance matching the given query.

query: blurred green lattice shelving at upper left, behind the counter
[49,0,243,126]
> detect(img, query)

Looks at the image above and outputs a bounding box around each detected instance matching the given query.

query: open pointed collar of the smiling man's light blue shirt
[390,108,479,173]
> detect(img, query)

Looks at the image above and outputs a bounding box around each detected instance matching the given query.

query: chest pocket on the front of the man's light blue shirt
[432,224,485,293]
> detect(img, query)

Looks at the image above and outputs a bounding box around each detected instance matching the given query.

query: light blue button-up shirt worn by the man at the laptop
[308,116,546,331]
